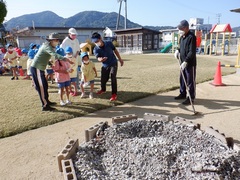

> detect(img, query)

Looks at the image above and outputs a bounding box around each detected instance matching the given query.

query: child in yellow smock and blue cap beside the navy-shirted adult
[80,52,97,99]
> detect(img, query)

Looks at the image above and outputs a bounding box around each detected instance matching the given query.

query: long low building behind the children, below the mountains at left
[6,27,104,48]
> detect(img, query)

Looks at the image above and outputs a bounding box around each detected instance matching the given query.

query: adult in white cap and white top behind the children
[60,28,81,91]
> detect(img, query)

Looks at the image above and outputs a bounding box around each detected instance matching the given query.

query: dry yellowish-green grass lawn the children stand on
[0,54,236,138]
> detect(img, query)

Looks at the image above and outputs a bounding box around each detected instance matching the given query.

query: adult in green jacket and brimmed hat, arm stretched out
[31,33,71,111]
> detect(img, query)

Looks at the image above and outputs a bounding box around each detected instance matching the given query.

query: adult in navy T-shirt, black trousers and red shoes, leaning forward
[92,32,123,101]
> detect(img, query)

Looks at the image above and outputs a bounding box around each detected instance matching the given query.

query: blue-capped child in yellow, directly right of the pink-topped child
[65,46,78,96]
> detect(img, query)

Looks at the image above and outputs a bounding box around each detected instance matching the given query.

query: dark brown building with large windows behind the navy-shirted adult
[114,27,161,54]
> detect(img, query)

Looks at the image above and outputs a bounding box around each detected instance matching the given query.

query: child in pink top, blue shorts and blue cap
[53,48,73,106]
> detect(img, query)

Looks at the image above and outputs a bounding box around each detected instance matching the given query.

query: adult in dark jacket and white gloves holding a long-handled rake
[175,20,197,105]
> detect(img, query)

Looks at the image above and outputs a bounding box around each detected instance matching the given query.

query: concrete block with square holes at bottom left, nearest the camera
[61,159,77,180]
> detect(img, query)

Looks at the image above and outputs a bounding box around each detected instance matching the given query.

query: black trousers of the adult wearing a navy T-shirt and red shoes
[101,64,118,94]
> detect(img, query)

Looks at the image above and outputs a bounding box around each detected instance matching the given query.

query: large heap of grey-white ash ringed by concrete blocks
[73,120,240,180]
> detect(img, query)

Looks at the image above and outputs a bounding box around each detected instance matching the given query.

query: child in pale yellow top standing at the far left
[4,44,18,80]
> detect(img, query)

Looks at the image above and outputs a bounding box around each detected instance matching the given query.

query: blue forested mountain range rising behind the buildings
[4,11,141,30]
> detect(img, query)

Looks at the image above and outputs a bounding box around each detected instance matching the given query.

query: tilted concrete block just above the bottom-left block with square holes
[57,139,79,172]
